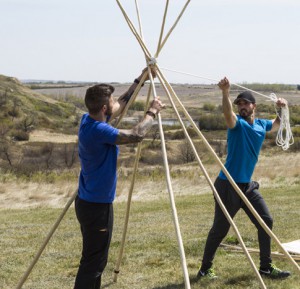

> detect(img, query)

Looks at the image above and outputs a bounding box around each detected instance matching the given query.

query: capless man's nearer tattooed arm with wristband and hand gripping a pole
[116,97,164,144]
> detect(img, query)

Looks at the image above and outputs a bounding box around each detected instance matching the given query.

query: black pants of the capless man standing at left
[74,197,113,289]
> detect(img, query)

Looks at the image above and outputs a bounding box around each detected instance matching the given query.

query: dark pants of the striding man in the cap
[201,178,273,271]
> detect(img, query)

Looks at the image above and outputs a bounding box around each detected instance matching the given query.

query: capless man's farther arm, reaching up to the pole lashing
[110,67,156,120]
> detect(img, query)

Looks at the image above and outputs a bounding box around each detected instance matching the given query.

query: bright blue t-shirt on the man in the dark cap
[219,115,272,183]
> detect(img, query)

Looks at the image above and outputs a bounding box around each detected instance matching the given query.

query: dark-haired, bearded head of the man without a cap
[84,83,115,114]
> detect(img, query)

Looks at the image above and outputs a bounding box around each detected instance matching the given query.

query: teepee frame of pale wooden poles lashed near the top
[16,0,300,289]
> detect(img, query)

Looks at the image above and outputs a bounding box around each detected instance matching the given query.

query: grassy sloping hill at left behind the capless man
[0,75,78,133]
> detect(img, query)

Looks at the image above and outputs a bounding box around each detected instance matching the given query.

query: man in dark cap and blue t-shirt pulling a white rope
[197,77,290,279]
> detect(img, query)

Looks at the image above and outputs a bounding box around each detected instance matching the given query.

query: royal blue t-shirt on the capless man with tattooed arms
[78,114,119,203]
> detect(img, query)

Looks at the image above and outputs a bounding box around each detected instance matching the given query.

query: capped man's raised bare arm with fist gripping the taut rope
[218,77,237,128]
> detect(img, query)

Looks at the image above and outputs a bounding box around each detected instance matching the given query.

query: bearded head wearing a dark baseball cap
[233,91,256,120]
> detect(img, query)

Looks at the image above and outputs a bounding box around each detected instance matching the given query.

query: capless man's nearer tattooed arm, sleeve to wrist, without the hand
[116,114,153,145]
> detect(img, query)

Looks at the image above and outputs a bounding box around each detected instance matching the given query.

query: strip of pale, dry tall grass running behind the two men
[0,148,300,209]
